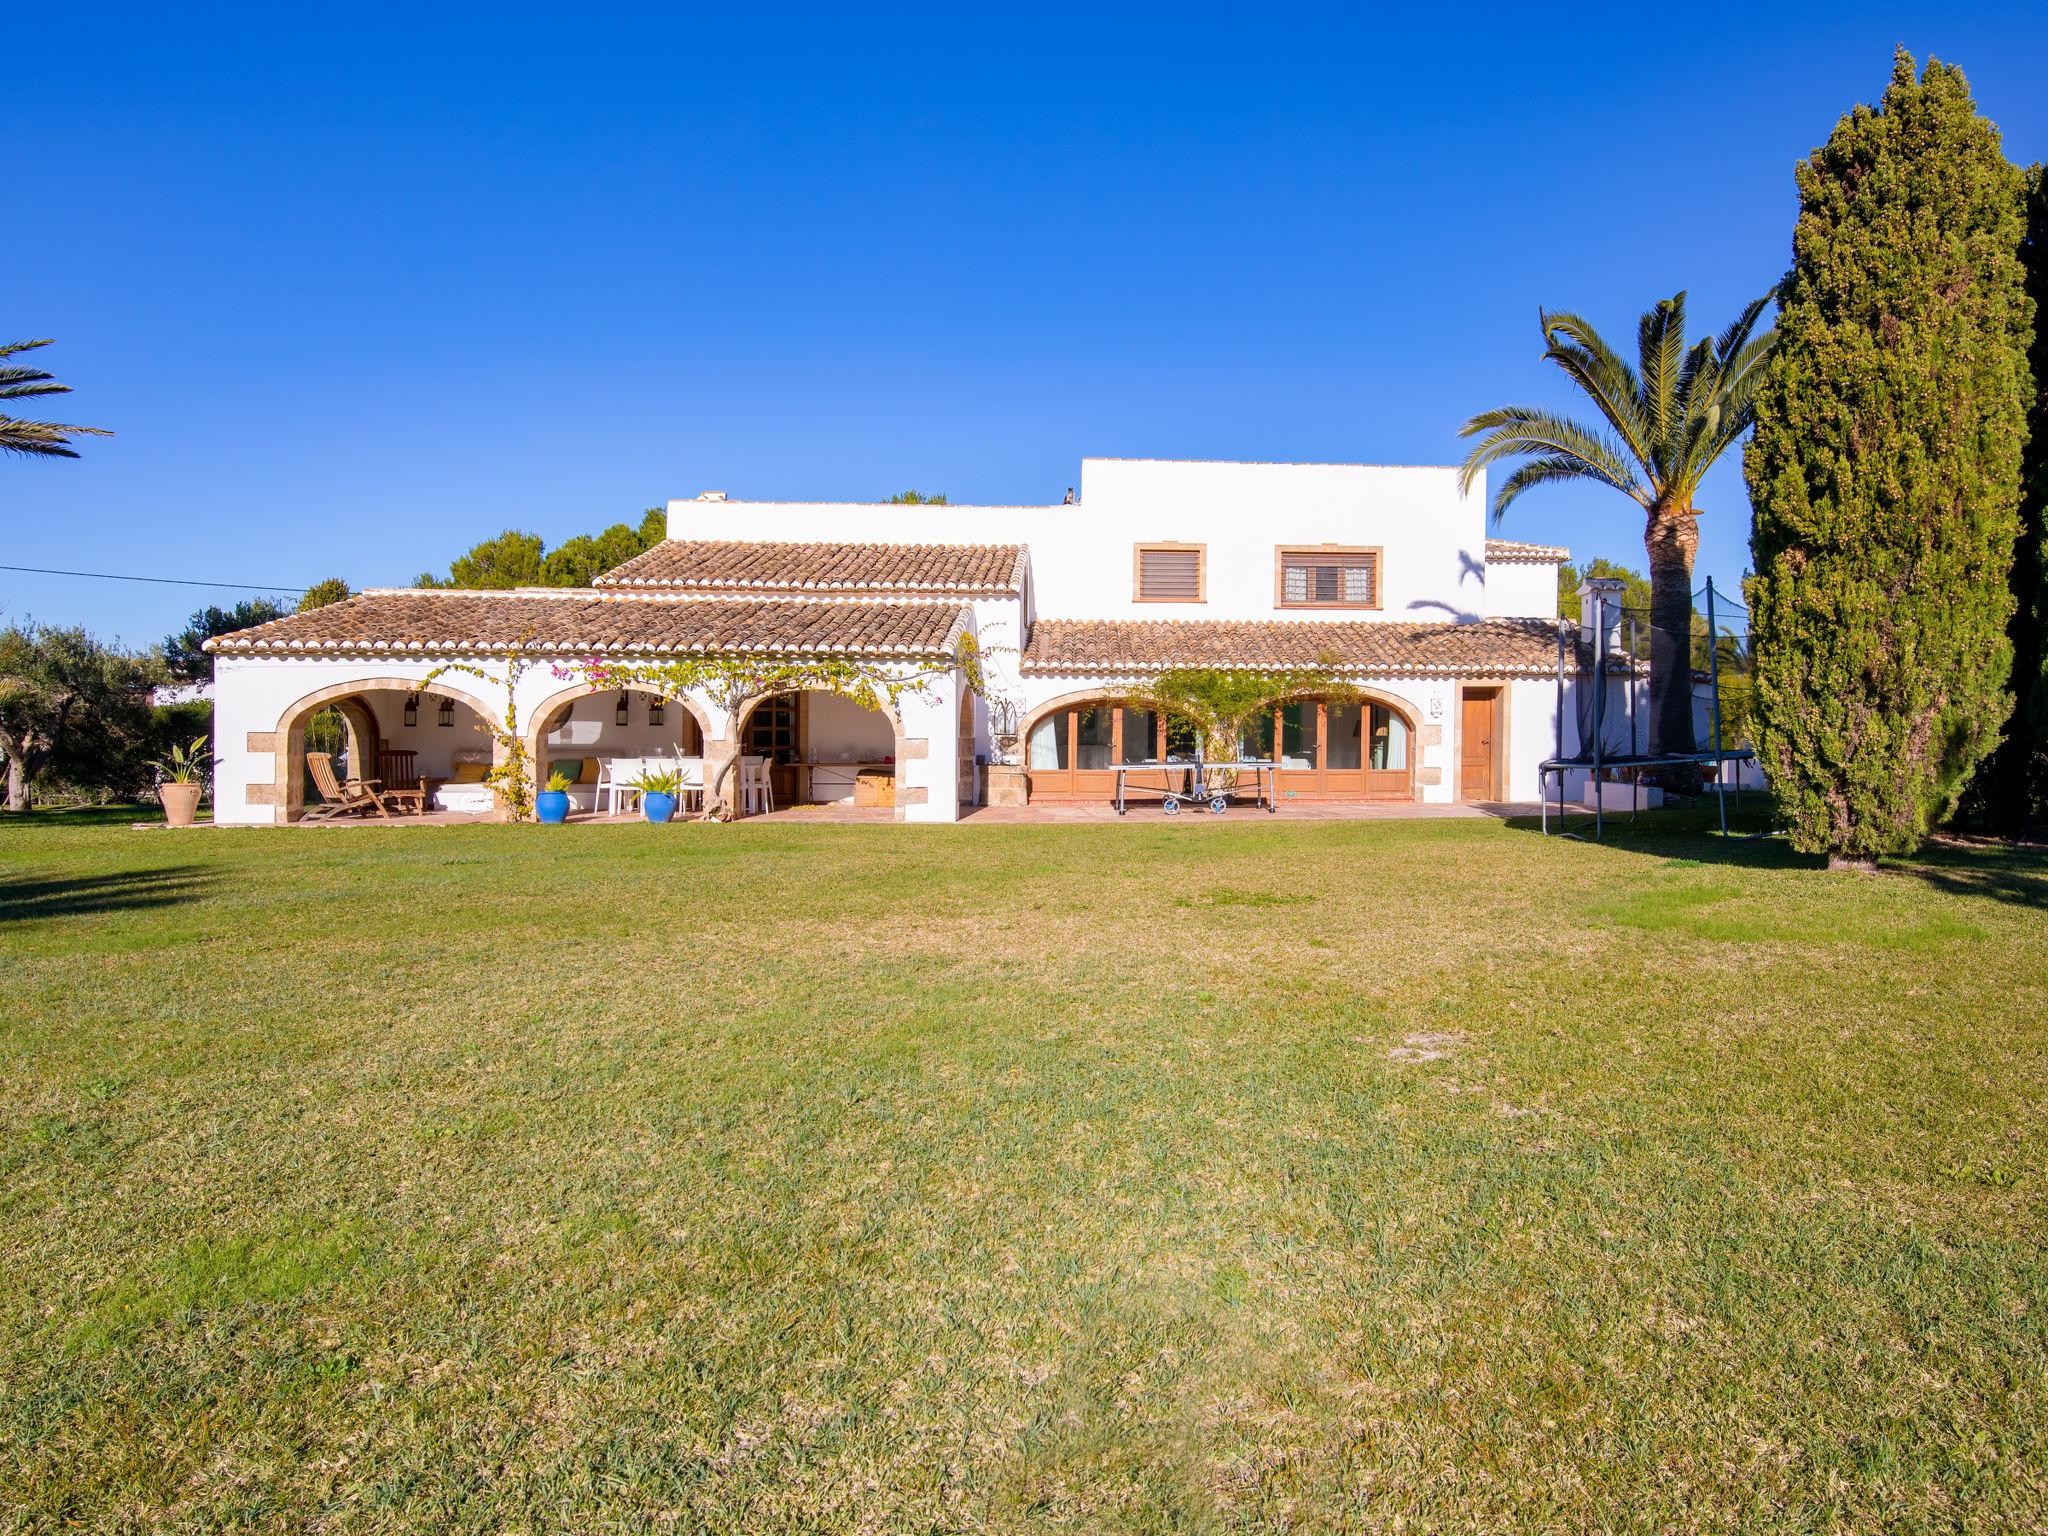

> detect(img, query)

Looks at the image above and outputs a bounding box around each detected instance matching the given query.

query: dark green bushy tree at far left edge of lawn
[0,625,162,811]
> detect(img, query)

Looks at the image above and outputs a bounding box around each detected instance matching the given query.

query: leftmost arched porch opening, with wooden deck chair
[272,678,498,821]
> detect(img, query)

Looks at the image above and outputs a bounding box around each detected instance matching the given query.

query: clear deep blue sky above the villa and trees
[0,4,2048,643]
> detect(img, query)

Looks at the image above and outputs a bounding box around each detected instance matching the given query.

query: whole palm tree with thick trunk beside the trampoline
[1458,293,1776,754]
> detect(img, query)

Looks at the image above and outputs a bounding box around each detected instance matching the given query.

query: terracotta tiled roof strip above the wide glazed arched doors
[1024,618,1556,678]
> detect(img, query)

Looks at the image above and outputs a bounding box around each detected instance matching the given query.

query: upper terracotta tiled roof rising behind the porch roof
[596,539,1024,596]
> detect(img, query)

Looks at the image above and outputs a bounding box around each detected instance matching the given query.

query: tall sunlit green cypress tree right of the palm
[1747,49,2034,862]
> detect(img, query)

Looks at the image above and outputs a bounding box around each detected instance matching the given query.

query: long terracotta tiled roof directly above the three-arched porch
[207,588,967,655]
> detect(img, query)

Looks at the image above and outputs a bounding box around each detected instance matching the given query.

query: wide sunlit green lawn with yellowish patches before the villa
[0,813,2048,1532]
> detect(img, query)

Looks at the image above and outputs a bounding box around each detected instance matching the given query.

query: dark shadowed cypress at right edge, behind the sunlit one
[1962,166,2048,838]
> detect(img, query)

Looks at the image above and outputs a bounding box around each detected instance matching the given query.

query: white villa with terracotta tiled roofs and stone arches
[209,459,1620,825]
